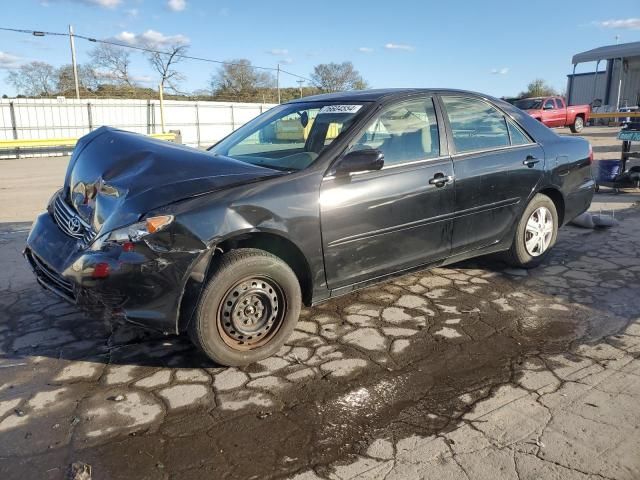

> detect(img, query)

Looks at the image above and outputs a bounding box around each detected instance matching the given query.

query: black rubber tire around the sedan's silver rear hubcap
[505,193,558,268]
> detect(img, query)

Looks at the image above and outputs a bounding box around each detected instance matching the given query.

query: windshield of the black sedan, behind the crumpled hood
[209,102,363,171]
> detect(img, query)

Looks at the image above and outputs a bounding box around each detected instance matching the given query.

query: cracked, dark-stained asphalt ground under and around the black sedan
[0,129,640,480]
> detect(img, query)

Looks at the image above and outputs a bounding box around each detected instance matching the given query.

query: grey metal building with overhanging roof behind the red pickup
[567,42,640,110]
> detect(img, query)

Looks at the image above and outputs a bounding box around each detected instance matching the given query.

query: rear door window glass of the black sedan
[442,97,509,153]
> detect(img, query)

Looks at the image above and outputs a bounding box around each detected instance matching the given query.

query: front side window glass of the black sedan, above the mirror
[350,98,440,166]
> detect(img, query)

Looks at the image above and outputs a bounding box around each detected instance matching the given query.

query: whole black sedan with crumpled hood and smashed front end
[24,89,594,365]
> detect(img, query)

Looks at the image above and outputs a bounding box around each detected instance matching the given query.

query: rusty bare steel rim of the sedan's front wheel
[217,276,286,351]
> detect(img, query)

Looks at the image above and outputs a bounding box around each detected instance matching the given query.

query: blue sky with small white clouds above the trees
[0,0,640,96]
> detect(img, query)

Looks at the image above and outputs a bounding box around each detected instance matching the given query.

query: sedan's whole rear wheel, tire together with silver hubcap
[507,194,558,268]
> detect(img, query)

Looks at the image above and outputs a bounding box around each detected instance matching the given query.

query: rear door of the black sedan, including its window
[441,95,544,255]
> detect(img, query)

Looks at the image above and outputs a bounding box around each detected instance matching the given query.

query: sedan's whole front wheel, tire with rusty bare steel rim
[189,248,302,366]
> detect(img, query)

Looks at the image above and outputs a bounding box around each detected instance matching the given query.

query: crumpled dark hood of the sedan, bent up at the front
[64,127,283,232]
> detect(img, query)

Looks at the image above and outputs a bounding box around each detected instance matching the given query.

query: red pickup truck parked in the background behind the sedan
[513,97,591,133]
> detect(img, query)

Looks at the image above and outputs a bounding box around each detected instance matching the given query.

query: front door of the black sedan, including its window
[320,97,454,289]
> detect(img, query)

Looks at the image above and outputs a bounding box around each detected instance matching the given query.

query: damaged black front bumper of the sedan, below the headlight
[24,213,203,333]
